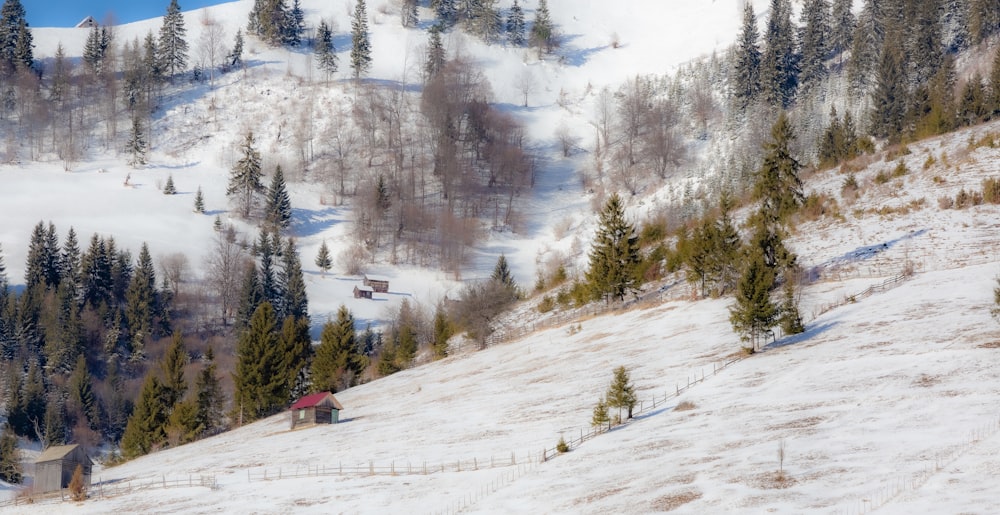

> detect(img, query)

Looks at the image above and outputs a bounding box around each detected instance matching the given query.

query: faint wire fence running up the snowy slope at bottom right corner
[837,417,1000,515]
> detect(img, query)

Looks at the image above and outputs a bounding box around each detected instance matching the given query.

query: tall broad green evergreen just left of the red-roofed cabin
[233,302,289,424]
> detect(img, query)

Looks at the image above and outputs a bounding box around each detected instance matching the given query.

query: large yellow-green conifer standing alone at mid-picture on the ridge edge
[587,193,639,300]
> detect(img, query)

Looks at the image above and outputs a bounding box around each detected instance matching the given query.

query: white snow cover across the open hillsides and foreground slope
[0,0,1000,513]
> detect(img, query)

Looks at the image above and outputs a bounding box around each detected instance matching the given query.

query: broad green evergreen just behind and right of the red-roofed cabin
[309,305,361,392]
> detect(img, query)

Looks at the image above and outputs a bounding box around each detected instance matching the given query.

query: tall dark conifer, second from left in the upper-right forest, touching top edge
[760,0,799,108]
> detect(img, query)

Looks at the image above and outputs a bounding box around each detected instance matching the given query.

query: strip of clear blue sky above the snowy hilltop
[21,0,227,27]
